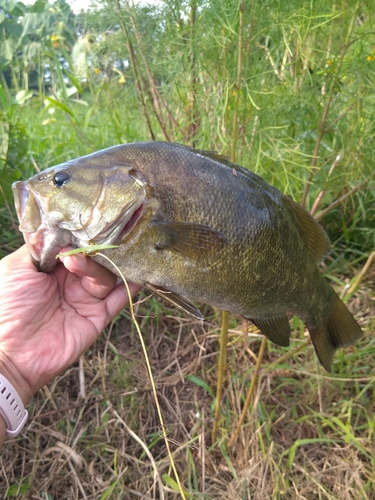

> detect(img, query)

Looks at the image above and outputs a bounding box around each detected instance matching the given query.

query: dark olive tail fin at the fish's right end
[308,292,362,372]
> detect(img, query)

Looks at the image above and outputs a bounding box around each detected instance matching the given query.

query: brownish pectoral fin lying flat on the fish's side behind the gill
[153,221,227,257]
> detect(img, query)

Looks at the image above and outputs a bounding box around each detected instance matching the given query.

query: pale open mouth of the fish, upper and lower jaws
[12,182,72,273]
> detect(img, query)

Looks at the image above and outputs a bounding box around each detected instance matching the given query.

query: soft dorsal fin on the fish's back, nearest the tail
[283,196,331,263]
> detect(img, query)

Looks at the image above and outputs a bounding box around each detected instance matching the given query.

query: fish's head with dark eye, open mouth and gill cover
[13,155,146,272]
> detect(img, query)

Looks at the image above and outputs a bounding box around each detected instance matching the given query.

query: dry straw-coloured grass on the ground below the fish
[0,269,375,500]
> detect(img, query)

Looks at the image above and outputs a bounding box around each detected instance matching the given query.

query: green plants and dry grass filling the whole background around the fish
[0,0,375,500]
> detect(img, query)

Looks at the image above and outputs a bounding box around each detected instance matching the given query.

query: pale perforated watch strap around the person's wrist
[0,373,29,437]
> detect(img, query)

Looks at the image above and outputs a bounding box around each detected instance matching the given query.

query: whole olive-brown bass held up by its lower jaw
[13,142,362,371]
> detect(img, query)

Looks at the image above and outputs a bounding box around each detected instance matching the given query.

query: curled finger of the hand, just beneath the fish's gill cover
[60,254,117,299]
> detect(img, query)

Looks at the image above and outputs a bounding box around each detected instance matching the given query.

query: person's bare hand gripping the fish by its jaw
[0,245,140,404]
